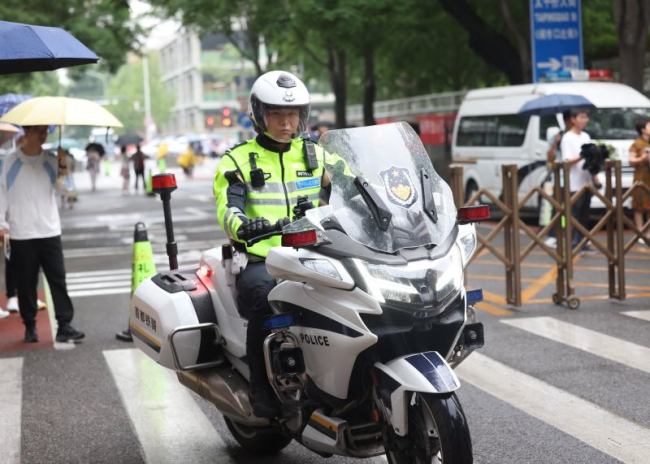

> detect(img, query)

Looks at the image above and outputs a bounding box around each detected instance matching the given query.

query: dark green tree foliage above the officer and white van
[142,0,632,110]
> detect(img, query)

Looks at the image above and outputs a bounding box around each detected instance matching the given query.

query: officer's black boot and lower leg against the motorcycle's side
[246,318,280,418]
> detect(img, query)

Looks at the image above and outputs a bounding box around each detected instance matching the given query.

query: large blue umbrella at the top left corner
[0,21,99,74]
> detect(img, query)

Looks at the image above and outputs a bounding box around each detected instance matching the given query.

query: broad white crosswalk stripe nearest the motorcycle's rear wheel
[104,349,232,464]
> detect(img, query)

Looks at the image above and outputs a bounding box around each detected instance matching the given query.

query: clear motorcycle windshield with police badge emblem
[310,122,456,253]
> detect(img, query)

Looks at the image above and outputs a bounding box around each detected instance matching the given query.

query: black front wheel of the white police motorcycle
[386,393,473,464]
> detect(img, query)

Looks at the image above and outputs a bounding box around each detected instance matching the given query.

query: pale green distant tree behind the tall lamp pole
[107,54,174,134]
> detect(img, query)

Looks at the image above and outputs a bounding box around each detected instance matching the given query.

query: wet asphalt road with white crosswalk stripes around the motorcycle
[0,160,650,464]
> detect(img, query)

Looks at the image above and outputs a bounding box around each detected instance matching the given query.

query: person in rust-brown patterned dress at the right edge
[630,119,650,246]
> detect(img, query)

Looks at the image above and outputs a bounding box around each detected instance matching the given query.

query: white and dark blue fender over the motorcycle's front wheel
[374,351,460,436]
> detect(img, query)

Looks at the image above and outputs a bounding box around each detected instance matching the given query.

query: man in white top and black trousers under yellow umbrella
[0,126,85,343]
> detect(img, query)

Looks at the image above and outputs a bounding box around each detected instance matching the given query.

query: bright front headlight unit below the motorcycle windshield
[353,246,463,309]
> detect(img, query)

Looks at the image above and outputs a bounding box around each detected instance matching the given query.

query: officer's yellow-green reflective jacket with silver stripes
[214,138,324,257]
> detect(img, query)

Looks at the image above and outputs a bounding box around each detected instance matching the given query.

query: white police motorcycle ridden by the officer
[129,123,489,464]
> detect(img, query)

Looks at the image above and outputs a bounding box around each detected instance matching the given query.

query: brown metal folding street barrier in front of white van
[450,160,650,309]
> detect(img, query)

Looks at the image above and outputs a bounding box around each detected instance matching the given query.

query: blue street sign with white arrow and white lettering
[530,0,584,82]
